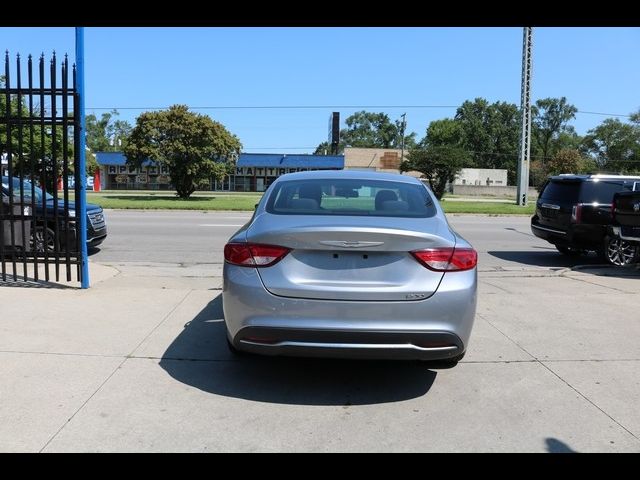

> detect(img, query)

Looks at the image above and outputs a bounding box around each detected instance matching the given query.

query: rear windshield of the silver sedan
[266,179,436,217]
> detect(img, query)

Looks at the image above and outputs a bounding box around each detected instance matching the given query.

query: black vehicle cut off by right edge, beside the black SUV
[608,190,640,265]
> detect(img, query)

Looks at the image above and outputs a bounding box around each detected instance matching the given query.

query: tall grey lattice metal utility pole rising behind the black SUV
[516,27,533,207]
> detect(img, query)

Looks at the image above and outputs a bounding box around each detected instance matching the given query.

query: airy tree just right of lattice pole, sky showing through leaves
[531,97,579,162]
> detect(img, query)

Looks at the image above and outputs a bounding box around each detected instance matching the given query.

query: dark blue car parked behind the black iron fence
[2,177,107,252]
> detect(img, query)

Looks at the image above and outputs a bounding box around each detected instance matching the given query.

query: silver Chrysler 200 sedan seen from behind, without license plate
[222,171,477,364]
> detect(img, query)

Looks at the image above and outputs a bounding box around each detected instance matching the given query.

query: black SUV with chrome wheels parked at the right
[531,174,640,265]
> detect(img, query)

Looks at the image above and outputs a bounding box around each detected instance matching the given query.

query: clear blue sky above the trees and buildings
[0,27,640,153]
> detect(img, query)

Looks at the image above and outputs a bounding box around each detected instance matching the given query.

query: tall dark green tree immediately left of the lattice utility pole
[455,98,520,183]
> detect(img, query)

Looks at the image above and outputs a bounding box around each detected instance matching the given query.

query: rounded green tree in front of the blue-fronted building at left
[124,105,242,199]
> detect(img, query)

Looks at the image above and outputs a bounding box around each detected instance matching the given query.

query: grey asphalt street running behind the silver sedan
[91,210,597,271]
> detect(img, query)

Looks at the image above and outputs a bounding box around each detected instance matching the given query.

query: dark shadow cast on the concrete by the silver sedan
[160,295,437,406]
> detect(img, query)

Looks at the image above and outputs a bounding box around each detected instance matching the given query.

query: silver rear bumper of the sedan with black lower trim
[222,264,477,360]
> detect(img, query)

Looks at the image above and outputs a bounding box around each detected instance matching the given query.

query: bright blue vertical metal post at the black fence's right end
[76,27,89,288]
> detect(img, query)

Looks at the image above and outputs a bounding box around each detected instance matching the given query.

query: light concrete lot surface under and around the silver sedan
[0,262,640,452]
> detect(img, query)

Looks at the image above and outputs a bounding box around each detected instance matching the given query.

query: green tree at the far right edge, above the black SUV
[583,117,640,173]
